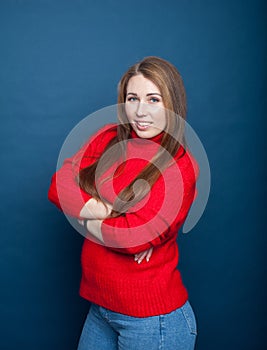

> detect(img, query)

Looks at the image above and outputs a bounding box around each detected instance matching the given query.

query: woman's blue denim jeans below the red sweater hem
[78,301,197,350]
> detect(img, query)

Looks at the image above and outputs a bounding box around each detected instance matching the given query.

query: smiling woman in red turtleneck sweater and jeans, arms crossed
[49,57,198,350]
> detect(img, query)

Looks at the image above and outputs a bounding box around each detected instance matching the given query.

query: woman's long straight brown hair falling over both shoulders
[77,56,186,216]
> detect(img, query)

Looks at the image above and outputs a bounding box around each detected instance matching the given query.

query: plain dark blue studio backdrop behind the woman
[0,0,267,350]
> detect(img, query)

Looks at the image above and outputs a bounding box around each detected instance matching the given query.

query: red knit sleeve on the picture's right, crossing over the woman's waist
[101,153,198,254]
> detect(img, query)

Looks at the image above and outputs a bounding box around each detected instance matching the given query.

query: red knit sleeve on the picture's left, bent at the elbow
[48,125,115,218]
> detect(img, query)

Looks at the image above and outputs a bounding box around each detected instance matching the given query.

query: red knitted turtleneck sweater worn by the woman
[48,125,199,317]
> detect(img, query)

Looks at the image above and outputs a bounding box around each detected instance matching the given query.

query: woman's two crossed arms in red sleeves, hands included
[48,127,199,262]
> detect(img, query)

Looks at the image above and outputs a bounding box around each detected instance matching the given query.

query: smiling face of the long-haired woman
[125,74,166,139]
